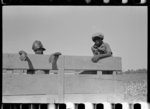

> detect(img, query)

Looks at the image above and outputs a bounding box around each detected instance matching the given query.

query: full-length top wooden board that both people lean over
[3,54,122,71]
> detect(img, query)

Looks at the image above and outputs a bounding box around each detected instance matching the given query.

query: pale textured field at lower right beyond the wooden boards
[118,73,148,102]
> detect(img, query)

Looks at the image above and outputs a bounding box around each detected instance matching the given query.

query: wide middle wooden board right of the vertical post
[64,76,115,94]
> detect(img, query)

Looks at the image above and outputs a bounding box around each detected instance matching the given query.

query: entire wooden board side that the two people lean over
[2,54,124,103]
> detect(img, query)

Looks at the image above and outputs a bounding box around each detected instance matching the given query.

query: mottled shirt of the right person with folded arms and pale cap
[91,42,112,55]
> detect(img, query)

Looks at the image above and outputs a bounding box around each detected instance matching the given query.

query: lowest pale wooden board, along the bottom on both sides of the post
[2,93,124,104]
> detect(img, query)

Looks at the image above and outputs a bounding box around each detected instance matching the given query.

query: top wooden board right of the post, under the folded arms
[64,56,122,71]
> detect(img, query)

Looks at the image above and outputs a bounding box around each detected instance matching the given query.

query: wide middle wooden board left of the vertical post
[2,74,59,96]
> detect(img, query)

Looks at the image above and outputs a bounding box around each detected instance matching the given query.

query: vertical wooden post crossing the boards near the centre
[58,56,64,103]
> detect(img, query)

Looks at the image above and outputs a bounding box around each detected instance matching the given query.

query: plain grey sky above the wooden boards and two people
[2,6,148,71]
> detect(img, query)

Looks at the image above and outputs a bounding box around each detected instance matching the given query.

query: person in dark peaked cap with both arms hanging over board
[19,40,61,74]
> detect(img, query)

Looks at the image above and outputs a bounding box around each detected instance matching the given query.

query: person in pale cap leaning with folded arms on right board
[91,33,112,62]
